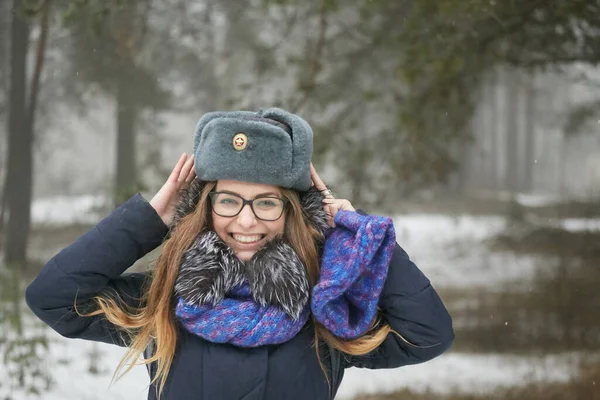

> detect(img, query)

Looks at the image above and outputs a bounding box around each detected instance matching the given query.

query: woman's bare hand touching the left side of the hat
[150,153,196,226]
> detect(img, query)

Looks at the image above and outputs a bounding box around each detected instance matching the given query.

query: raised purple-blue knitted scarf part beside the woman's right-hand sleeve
[311,211,396,339]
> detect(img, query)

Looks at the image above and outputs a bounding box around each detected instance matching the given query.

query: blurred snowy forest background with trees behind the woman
[0,0,600,400]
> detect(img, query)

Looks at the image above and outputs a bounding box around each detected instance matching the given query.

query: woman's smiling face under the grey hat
[211,180,285,261]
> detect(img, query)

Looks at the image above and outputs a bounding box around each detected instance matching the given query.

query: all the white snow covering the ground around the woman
[0,197,600,400]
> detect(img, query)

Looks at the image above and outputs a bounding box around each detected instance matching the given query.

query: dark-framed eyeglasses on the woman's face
[209,192,287,221]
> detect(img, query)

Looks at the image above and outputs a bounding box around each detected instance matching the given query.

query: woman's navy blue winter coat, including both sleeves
[26,194,454,400]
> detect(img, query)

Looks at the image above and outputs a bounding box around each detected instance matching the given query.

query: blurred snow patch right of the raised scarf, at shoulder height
[394,214,539,290]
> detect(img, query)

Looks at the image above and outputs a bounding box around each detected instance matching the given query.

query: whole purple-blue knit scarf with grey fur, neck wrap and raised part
[175,181,396,347]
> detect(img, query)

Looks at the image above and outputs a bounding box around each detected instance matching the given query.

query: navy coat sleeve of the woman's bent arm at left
[25,194,167,346]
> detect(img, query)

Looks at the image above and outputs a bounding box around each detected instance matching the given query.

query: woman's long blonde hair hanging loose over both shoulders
[83,182,391,398]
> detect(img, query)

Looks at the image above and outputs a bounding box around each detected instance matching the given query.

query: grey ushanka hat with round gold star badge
[194,108,313,191]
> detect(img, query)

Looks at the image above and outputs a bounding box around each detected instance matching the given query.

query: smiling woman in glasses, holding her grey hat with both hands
[26,108,454,400]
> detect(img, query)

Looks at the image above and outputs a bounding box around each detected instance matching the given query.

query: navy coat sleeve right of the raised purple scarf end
[345,244,454,369]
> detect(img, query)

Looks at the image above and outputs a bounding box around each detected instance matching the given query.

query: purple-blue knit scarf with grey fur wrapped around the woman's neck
[175,231,310,347]
